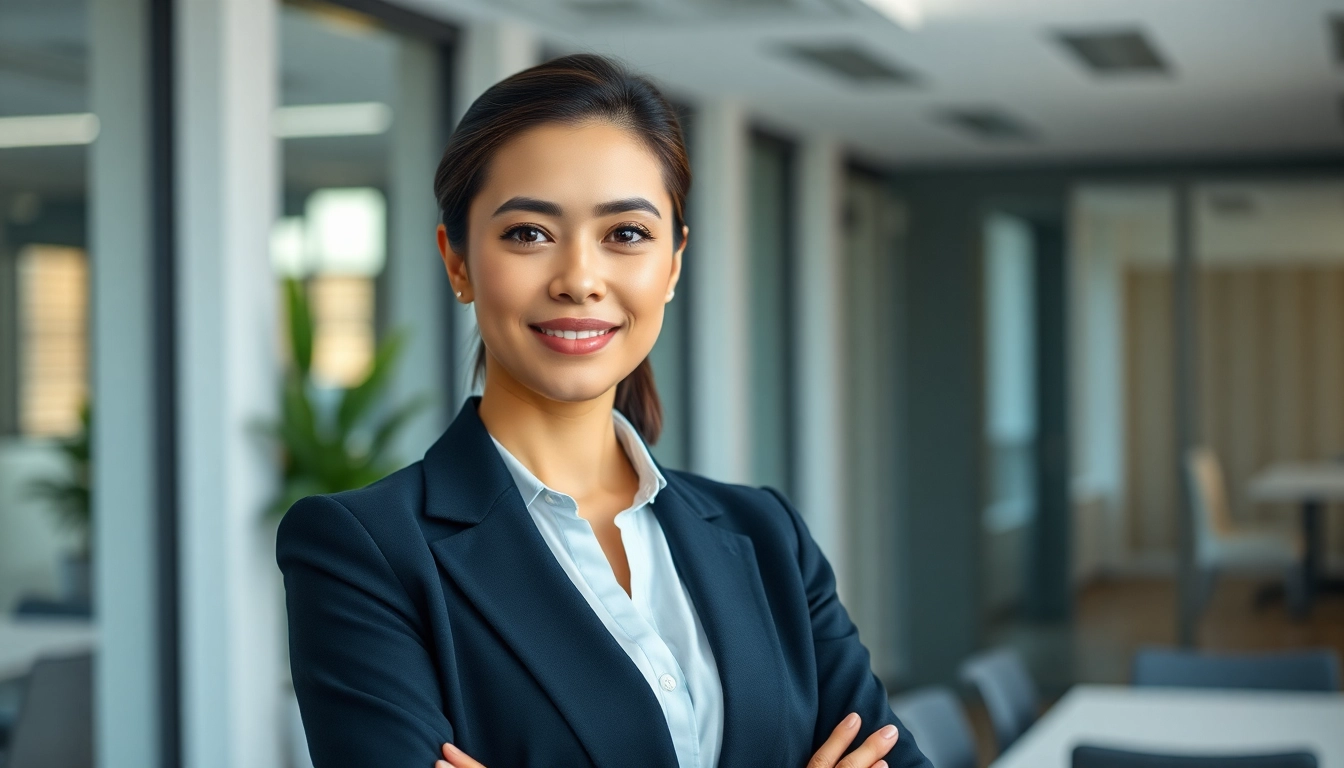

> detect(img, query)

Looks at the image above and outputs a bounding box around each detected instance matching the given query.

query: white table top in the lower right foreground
[992,686,1344,768]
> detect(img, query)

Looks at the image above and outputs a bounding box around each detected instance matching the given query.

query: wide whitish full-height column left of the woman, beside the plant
[176,0,282,768]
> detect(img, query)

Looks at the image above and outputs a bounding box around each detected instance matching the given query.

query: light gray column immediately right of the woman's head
[687,101,751,483]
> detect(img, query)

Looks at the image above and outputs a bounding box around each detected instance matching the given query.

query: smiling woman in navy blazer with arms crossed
[277,55,927,768]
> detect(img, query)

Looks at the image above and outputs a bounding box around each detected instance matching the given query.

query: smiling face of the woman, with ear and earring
[438,121,684,402]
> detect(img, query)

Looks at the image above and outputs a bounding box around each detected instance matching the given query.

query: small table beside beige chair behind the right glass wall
[1247,461,1344,613]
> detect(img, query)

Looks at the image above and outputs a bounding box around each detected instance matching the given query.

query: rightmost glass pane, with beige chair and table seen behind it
[1192,179,1344,632]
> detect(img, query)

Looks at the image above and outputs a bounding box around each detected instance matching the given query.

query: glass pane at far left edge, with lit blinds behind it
[0,0,98,736]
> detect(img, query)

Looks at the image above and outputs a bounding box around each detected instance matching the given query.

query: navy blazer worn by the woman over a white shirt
[276,399,929,768]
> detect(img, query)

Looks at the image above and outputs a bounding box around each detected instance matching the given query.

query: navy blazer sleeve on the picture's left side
[276,496,453,768]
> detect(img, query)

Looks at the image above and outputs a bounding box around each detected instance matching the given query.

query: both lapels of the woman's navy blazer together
[423,398,789,768]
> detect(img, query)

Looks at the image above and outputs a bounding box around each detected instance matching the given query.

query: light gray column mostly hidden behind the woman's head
[453,22,542,410]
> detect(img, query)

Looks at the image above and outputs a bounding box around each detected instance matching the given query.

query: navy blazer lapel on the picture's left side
[425,399,676,768]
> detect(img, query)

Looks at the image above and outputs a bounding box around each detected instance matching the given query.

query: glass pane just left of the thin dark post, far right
[1068,186,1180,683]
